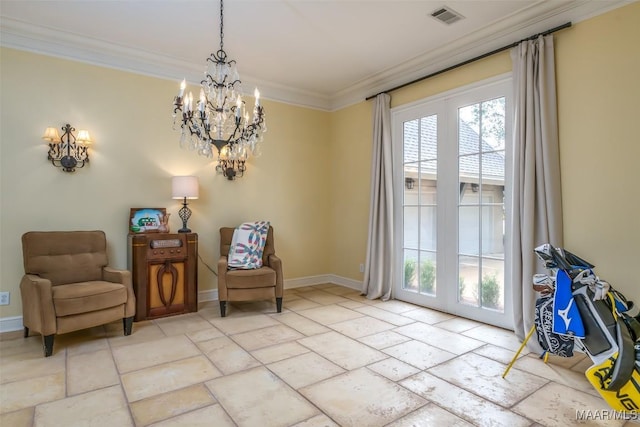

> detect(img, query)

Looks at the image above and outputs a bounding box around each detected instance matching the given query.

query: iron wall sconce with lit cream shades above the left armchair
[42,123,91,172]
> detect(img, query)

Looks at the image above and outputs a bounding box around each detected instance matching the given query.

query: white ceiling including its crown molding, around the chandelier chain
[0,0,629,110]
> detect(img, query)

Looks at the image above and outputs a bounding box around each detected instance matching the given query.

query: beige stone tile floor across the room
[0,284,635,427]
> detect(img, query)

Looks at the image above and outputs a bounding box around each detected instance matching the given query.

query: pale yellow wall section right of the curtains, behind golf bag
[556,2,640,304]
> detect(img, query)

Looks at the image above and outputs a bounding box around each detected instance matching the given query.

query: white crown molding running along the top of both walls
[0,0,633,111]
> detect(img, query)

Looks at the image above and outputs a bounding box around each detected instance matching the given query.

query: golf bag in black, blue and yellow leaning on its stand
[533,244,640,411]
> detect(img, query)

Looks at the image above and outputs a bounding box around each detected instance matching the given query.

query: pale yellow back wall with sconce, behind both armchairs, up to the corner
[0,49,331,318]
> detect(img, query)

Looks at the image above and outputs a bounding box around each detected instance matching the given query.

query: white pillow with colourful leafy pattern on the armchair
[228,221,269,270]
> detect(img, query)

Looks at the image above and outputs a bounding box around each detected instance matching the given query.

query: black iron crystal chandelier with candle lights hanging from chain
[173,0,267,180]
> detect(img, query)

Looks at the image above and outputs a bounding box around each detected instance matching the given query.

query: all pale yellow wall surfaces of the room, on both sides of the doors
[0,3,640,318]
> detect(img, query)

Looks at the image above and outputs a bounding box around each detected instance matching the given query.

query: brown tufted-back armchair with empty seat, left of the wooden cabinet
[20,231,136,357]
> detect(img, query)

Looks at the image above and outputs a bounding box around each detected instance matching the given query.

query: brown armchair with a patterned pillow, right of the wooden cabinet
[218,226,283,317]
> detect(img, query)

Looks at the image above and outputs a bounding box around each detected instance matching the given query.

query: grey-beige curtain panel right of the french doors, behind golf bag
[510,35,563,350]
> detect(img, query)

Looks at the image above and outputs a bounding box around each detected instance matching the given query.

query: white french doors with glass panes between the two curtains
[392,78,513,328]
